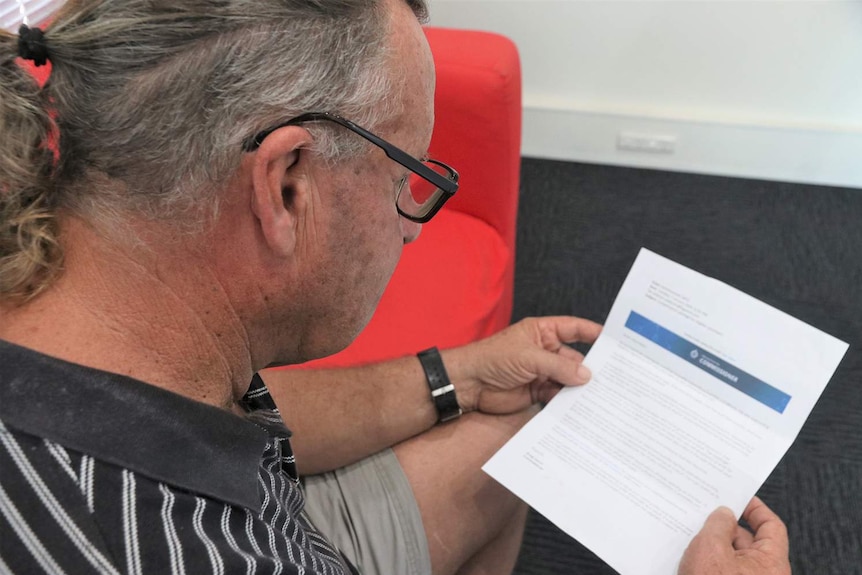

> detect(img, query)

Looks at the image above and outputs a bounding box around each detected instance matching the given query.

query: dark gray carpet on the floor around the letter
[514,159,862,575]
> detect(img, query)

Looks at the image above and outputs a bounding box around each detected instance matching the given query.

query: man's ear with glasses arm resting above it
[251,126,312,256]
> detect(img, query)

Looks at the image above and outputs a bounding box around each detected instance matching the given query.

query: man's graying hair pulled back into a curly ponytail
[0,0,426,301]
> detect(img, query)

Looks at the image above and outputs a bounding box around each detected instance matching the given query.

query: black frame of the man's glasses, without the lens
[242,112,458,224]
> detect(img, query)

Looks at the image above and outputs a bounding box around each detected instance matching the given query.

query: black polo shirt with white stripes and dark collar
[0,341,353,575]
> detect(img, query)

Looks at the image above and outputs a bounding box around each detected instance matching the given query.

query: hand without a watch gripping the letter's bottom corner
[679,497,790,575]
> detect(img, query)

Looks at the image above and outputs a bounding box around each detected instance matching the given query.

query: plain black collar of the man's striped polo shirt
[0,340,290,510]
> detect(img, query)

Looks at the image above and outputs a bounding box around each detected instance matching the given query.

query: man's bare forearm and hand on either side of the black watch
[261,317,601,474]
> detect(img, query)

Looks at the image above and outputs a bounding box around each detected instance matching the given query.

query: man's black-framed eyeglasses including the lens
[242,112,458,224]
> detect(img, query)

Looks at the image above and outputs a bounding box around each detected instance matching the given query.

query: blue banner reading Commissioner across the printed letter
[626,311,790,413]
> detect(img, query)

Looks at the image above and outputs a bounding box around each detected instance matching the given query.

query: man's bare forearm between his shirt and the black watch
[261,357,437,474]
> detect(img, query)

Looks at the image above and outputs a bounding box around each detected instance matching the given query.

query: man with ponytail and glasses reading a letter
[0,0,789,575]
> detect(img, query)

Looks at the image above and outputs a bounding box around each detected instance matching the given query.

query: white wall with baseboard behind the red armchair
[430,0,862,187]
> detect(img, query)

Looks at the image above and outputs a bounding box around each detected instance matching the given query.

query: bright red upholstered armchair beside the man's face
[288,28,521,367]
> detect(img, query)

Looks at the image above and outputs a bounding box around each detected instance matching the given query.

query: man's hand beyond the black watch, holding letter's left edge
[443,317,602,414]
